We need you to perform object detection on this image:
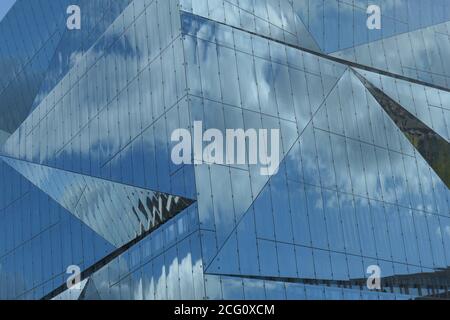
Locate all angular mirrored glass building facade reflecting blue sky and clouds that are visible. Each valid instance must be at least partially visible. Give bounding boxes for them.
[0,0,450,300]
